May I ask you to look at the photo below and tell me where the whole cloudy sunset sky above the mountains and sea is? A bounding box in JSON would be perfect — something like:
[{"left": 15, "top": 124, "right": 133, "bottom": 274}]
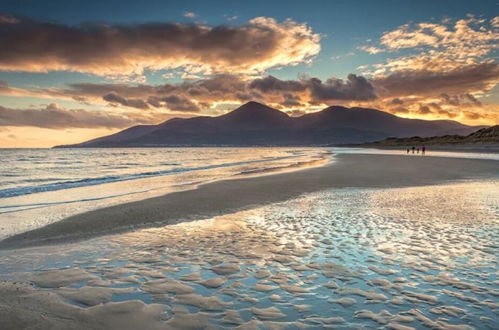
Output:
[{"left": 0, "top": 0, "right": 499, "bottom": 148}]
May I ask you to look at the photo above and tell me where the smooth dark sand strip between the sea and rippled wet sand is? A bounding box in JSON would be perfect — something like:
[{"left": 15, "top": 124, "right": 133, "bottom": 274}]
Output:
[{"left": 0, "top": 154, "right": 499, "bottom": 249}]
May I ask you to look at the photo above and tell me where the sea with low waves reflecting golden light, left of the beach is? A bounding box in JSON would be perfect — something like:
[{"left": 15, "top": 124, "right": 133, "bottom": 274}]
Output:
[{"left": 0, "top": 148, "right": 330, "bottom": 239}]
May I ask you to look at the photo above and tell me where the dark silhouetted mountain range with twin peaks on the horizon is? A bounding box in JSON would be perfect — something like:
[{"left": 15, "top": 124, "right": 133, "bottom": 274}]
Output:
[{"left": 58, "top": 102, "right": 483, "bottom": 148}]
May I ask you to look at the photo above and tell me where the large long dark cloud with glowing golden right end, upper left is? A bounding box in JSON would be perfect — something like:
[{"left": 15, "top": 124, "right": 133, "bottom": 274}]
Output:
[{"left": 0, "top": 16, "right": 320, "bottom": 76}]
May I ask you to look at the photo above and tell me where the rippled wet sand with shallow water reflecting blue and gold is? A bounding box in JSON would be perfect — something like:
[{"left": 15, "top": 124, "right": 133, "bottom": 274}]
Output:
[{"left": 0, "top": 181, "right": 499, "bottom": 329}]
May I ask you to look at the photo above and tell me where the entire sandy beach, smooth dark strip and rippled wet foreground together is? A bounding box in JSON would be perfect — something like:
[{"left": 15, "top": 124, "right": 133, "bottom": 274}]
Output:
[{"left": 0, "top": 153, "right": 499, "bottom": 329}]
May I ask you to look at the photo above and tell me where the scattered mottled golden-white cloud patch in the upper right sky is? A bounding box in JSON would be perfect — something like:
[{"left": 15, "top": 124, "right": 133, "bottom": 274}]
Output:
[{"left": 359, "top": 16, "right": 499, "bottom": 75}]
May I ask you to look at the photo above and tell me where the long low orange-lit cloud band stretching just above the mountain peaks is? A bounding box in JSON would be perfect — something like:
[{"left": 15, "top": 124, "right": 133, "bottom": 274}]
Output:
[{"left": 0, "top": 70, "right": 499, "bottom": 124}]
